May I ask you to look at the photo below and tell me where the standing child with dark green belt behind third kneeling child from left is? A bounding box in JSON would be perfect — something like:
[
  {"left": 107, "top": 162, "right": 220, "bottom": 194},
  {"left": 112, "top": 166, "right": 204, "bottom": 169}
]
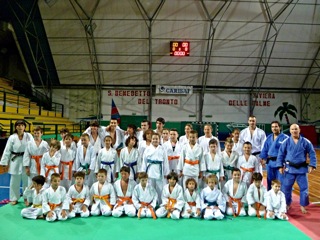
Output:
[{"left": 73, "top": 133, "right": 96, "bottom": 188}]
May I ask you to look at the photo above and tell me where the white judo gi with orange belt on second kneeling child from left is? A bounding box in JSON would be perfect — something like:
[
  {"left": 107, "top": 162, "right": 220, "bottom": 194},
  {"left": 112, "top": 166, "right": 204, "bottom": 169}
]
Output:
[{"left": 42, "top": 186, "right": 69, "bottom": 222}]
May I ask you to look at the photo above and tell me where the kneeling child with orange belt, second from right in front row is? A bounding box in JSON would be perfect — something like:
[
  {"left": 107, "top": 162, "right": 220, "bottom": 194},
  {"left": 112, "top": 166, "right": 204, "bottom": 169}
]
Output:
[{"left": 247, "top": 173, "right": 267, "bottom": 218}]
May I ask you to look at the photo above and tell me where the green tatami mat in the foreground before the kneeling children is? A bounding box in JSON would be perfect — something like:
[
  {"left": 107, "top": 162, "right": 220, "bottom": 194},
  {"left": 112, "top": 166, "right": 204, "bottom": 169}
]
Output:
[{"left": 0, "top": 203, "right": 309, "bottom": 240}]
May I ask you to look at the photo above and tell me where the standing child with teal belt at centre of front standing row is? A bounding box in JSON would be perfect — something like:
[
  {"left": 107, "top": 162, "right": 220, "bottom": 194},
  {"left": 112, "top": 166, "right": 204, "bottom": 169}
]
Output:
[{"left": 142, "top": 133, "right": 169, "bottom": 204}]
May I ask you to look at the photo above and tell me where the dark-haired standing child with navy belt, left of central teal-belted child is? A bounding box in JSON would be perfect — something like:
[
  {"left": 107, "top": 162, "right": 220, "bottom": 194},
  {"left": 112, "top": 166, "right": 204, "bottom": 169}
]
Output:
[{"left": 119, "top": 136, "right": 142, "bottom": 180}]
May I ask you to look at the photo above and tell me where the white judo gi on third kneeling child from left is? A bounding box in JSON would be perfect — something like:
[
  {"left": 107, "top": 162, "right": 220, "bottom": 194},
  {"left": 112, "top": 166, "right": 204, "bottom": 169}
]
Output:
[{"left": 67, "top": 184, "right": 91, "bottom": 218}]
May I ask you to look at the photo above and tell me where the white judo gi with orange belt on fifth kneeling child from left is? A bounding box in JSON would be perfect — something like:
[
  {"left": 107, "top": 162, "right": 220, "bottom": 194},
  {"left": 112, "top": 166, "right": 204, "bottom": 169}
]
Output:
[{"left": 112, "top": 179, "right": 137, "bottom": 217}]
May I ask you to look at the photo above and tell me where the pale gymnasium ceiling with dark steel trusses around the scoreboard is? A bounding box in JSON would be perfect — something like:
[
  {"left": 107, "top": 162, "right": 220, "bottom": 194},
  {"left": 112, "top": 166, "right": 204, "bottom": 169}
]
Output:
[{"left": 1, "top": 0, "right": 320, "bottom": 91}]
